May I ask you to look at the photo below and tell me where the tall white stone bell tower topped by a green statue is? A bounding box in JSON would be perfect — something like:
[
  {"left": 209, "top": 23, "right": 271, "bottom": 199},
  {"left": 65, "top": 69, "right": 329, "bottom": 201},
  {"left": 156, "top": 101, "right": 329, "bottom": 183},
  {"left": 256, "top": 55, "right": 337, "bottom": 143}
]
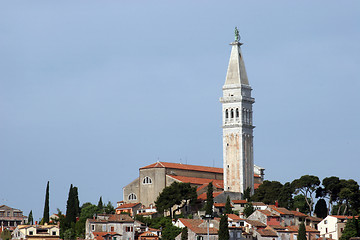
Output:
[{"left": 220, "top": 28, "right": 255, "bottom": 194}]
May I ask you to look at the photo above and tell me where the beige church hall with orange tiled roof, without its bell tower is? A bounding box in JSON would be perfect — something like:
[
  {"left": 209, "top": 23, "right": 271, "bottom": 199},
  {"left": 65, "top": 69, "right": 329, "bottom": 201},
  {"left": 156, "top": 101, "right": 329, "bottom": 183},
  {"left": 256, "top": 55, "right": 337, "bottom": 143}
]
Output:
[{"left": 123, "top": 162, "right": 264, "bottom": 206}]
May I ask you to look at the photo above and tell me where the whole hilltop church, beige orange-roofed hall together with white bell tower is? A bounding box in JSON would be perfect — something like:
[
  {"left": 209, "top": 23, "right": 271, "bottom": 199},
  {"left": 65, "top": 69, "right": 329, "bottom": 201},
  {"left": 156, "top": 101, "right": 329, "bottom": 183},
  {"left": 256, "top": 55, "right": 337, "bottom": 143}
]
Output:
[{"left": 123, "top": 29, "right": 265, "bottom": 206}]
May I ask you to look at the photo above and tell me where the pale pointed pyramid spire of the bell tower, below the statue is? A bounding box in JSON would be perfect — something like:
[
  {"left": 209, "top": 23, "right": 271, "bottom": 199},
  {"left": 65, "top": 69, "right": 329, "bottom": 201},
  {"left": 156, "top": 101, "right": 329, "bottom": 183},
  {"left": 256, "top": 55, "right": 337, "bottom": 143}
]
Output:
[{"left": 225, "top": 42, "right": 249, "bottom": 85}]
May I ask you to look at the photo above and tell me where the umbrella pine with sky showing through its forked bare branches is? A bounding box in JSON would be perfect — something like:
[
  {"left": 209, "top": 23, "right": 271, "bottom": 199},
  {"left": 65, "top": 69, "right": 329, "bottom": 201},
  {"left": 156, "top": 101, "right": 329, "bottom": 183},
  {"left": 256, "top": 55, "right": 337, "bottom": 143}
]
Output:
[{"left": 291, "top": 175, "right": 320, "bottom": 214}]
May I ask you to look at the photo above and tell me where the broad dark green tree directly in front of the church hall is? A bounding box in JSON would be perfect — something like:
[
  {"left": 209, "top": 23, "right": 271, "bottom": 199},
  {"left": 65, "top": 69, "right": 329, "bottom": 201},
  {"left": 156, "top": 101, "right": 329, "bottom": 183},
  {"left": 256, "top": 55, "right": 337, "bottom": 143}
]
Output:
[{"left": 155, "top": 182, "right": 197, "bottom": 218}]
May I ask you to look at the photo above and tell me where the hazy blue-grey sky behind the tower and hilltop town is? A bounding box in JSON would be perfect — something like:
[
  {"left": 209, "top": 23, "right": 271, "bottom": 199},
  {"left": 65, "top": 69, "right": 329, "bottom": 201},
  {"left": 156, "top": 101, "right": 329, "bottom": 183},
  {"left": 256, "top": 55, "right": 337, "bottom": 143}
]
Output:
[{"left": 0, "top": 0, "right": 360, "bottom": 220}]
